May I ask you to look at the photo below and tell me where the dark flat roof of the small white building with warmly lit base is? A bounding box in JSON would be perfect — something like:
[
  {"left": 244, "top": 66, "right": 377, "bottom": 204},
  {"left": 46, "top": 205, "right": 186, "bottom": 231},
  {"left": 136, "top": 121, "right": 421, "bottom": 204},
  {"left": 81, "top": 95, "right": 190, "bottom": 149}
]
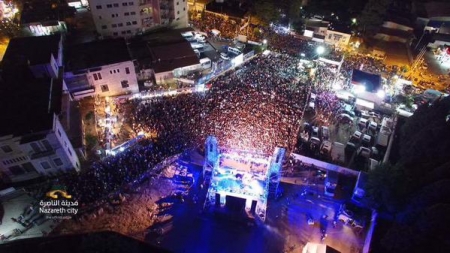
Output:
[{"left": 65, "top": 38, "right": 131, "bottom": 72}]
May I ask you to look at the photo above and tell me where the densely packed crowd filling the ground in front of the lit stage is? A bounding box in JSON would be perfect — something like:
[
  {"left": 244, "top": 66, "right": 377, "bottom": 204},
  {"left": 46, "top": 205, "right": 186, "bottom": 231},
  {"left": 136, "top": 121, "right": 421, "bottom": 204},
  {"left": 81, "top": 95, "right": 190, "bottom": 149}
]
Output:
[{"left": 134, "top": 54, "right": 308, "bottom": 152}]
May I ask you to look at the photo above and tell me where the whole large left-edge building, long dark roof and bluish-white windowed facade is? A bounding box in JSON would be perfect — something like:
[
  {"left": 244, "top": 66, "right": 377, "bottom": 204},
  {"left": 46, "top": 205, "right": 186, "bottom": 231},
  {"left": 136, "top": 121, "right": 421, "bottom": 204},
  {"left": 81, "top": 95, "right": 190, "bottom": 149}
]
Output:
[{"left": 0, "top": 35, "right": 80, "bottom": 182}]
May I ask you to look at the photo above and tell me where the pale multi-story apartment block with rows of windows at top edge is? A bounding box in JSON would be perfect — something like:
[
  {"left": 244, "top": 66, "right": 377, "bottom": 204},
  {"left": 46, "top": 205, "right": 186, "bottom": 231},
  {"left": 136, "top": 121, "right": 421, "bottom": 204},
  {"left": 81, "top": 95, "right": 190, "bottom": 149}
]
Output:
[{"left": 89, "top": 0, "right": 188, "bottom": 37}]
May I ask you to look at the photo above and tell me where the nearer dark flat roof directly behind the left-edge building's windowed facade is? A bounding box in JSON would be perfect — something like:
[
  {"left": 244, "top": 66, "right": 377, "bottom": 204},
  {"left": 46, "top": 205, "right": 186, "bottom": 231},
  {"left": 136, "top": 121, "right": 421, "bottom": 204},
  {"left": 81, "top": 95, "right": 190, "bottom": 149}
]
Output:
[{"left": 0, "top": 66, "right": 62, "bottom": 136}]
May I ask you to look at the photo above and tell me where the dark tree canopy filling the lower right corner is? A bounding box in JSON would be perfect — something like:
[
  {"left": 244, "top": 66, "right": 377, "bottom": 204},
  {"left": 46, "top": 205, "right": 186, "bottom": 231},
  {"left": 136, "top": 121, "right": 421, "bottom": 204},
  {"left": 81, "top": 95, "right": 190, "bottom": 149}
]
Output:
[{"left": 367, "top": 97, "right": 450, "bottom": 253}]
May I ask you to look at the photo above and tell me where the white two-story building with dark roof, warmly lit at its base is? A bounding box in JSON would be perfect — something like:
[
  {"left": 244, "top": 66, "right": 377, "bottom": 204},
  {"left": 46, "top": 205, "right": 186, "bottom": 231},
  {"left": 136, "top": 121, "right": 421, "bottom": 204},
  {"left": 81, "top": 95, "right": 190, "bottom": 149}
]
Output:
[{"left": 64, "top": 38, "right": 139, "bottom": 100}]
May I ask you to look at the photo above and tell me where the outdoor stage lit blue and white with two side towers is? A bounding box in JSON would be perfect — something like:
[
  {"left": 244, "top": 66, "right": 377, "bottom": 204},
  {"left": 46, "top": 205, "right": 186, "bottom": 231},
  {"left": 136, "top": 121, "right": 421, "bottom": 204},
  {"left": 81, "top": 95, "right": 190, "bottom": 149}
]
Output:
[{"left": 203, "top": 137, "right": 285, "bottom": 221}]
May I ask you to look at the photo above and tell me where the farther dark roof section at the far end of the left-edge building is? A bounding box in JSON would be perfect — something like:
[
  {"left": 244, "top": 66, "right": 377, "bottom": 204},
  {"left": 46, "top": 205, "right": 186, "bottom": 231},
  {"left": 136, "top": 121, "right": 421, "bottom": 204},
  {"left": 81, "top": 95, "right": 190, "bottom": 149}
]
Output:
[{"left": 2, "top": 34, "right": 61, "bottom": 68}]
